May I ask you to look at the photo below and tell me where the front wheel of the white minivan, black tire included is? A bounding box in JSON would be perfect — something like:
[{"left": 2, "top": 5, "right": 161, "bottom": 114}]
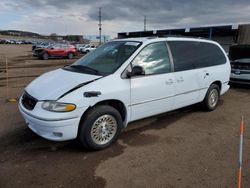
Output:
[{"left": 78, "top": 105, "right": 123, "bottom": 150}]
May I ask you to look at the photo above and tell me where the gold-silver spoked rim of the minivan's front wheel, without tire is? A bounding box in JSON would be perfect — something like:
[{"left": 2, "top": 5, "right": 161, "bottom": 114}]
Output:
[{"left": 91, "top": 115, "right": 117, "bottom": 145}]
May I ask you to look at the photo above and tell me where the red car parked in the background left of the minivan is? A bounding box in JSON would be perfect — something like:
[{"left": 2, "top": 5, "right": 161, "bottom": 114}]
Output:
[{"left": 33, "top": 44, "right": 77, "bottom": 60}]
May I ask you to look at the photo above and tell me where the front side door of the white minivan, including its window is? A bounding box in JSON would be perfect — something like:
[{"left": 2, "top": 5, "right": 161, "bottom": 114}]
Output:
[{"left": 130, "top": 42, "right": 175, "bottom": 121}]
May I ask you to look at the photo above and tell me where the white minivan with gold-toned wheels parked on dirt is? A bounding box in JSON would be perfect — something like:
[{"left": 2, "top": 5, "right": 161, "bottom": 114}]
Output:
[{"left": 19, "top": 37, "right": 230, "bottom": 149}]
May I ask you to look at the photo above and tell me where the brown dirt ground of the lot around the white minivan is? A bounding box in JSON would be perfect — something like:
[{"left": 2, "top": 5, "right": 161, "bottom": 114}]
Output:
[{"left": 0, "top": 45, "right": 250, "bottom": 188}]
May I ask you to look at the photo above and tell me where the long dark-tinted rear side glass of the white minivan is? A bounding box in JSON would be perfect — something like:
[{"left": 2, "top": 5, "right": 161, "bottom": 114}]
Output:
[{"left": 168, "top": 41, "right": 226, "bottom": 71}]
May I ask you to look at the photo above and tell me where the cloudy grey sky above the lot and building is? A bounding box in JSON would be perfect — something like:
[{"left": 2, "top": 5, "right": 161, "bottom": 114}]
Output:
[{"left": 0, "top": 0, "right": 250, "bottom": 37}]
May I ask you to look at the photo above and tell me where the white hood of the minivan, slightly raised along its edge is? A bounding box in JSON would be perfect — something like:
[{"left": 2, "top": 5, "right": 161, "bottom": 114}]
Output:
[{"left": 25, "top": 69, "right": 101, "bottom": 100}]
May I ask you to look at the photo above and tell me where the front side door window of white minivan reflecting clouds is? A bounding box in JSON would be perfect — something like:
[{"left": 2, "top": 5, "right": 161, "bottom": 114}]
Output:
[{"left": 132, "top": 42, "right": 171, "bottom": 75}]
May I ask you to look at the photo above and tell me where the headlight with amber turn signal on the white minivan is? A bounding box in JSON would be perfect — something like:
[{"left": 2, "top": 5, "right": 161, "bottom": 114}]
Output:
[{"left": 42, "top": 101, "right": 76, "bottom": 112}]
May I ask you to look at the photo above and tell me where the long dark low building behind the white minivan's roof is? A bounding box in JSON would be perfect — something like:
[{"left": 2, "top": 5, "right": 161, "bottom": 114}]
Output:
[{"left": 118, "top": 24, "right": 250, "bottom": 52}]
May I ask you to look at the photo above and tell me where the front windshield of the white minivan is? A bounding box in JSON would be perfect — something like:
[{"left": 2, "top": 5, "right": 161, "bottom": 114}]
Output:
[{"left": 65, "top": 41, "right": 141, "bottom": 75}]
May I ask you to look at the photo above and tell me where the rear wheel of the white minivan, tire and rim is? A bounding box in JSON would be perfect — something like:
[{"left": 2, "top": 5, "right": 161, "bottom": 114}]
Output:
[{"left": 203, "top": 84, "right": 220, "bottom": 111}]
